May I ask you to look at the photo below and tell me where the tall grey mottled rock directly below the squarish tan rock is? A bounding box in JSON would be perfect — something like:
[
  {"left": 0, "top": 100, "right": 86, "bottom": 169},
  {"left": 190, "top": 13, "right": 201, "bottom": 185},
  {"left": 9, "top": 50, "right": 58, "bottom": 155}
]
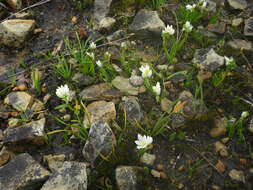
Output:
[{"left": 83, "top": 121, "right": 116, "bottom": 166}]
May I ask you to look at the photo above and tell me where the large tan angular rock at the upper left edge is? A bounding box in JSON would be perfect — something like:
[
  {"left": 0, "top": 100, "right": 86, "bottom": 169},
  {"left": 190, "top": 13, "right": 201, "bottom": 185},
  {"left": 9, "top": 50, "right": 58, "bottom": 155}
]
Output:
[{"left": 0, "top": 19, "right": 35, "bottom": 47}]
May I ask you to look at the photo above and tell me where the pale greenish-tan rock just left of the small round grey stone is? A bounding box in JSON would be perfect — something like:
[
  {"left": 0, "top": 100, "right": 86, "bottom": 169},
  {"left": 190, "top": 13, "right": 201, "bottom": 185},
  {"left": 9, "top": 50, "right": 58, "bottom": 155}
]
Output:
[{"left": 112, "top": 76, "right": 142, "bottom": 95}]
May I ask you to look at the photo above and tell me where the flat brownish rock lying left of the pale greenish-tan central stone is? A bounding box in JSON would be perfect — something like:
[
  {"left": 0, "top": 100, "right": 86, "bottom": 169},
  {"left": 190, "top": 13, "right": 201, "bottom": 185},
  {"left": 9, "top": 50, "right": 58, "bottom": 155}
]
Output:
[{"left": 79, "top": 83, "right": 122, "bottom": 100}]
